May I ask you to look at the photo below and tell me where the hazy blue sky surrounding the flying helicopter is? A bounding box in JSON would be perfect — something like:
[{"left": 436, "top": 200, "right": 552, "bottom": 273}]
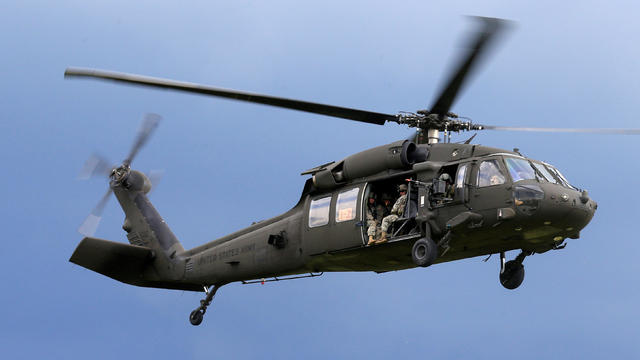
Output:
[{"left": 0, "top": 1, "right": 640, "bottom": 359}]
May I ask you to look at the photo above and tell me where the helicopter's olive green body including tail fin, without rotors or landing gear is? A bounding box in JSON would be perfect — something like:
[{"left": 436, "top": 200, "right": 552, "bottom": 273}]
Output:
[{"left": 70, "top": 141, "right": 597, "bottom": 291}]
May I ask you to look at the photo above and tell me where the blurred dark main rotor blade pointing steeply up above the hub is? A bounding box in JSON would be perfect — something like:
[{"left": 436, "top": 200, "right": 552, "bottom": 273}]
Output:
[{"left": 429, "top": 17, "right": 508, "bottom": 116}]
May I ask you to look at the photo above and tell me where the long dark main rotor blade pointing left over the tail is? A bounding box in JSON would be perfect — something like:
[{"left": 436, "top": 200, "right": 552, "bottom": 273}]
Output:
[{"left": 64, "top": 68, "right": 398, "bottom": 125}]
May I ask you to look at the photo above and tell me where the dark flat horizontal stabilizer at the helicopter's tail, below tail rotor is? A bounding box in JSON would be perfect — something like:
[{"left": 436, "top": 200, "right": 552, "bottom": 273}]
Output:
[{"left": 69, "top": 237, "right": 153, "bottom": 286}]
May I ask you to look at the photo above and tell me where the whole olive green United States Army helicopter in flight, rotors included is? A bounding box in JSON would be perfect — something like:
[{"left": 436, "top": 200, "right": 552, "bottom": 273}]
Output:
[{"left": 65, "top": 18, "right": 640, "bottom": 326}]
